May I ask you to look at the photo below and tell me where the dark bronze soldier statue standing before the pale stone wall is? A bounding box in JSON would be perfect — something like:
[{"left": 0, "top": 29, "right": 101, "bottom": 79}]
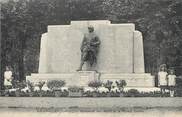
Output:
[{"left": 77, "top": 26, "right": 101, "bottom": 71}]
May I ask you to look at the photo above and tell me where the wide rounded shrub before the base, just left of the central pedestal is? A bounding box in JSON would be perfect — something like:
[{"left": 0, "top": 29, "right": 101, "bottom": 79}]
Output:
[{"left": 47, "top": 80, "right": 66, "bottom": 90}]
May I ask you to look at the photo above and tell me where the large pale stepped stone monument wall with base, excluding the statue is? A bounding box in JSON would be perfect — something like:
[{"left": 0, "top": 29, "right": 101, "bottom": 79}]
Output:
[{"left": 27, "top": 20, "right": 154, "bottom": 87}]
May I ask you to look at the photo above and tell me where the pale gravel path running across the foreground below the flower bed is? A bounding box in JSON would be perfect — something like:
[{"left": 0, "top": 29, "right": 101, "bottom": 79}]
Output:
[{"left": 0, "top": 97, "right": 182, "bottom": 110}]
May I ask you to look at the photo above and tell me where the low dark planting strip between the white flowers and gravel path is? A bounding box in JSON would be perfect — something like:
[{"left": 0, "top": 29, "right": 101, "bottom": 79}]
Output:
[{"left": 1, "top": 89, "right": 172, "bottom": 97}]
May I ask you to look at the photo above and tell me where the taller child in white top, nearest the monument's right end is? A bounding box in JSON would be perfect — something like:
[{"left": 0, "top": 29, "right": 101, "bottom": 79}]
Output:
[{"left": 158, "top": 64, "right": 168, "bottom": 97}]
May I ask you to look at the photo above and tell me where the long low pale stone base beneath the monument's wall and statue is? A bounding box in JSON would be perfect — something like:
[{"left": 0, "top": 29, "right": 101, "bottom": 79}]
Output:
[{"left": 26, "top": 71, "right": 155, "bottom": 87}]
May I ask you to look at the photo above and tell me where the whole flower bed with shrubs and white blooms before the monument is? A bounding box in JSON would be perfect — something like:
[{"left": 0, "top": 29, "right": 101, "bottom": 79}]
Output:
[{"left": 0, "top": 80, "right": 179, "bottom": 97}]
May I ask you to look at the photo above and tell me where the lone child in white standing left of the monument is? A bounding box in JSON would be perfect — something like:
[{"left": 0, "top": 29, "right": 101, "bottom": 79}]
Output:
[{"left": 4, "top": 66, "right": 13, "bottom": 89}]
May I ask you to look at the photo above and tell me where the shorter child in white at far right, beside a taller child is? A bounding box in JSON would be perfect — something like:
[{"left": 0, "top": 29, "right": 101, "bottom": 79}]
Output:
[{"left": 168, "top": 69, "right": 176, "bottom": 97}]
